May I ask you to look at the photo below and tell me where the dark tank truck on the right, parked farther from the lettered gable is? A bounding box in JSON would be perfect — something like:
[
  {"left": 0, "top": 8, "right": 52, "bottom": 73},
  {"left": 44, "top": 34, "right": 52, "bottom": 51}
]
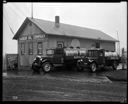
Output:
[{"left": 78, "top": 49, "right": 121, "bottom": 72}]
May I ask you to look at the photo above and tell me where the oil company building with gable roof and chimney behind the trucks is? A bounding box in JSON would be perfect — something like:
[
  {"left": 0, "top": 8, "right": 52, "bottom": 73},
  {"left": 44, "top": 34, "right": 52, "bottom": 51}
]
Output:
[{"left": 13, "top": 16, "right": 117, "bottom": 68}]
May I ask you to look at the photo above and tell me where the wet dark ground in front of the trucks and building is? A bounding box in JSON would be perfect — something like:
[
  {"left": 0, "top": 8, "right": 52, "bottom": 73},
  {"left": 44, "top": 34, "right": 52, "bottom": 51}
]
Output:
[{"left": 3, "top": 69, "right": 127, "bottom": 102}]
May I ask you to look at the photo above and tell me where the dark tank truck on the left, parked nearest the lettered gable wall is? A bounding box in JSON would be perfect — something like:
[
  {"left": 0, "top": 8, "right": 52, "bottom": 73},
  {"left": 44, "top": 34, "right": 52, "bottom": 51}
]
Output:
[{"left": 32, "top": 47, "right": 87, "bottom": 73}]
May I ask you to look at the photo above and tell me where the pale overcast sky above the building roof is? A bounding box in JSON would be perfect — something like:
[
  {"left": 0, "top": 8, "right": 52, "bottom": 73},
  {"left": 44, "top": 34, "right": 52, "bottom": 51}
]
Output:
[{"left": 3, "top": 2, "right": 127, "bottom": 53}]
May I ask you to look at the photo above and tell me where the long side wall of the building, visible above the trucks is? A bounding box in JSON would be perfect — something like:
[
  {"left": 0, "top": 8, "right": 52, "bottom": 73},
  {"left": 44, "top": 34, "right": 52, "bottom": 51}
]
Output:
[{"left": 48, "top": 35, "right": 115, "bottom": 51}]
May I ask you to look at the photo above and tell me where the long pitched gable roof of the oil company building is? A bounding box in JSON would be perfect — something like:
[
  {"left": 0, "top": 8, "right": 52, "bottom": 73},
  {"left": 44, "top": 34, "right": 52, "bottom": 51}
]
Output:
[{"left": 13, "top": 17, "right": 118, "bottom": 42}]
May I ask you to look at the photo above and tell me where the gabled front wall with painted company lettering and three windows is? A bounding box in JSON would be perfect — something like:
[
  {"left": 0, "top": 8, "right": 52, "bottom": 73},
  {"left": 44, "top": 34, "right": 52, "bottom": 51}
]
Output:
[{"left": 18, "top": 23, "right": 47, "bottom": 68}]
